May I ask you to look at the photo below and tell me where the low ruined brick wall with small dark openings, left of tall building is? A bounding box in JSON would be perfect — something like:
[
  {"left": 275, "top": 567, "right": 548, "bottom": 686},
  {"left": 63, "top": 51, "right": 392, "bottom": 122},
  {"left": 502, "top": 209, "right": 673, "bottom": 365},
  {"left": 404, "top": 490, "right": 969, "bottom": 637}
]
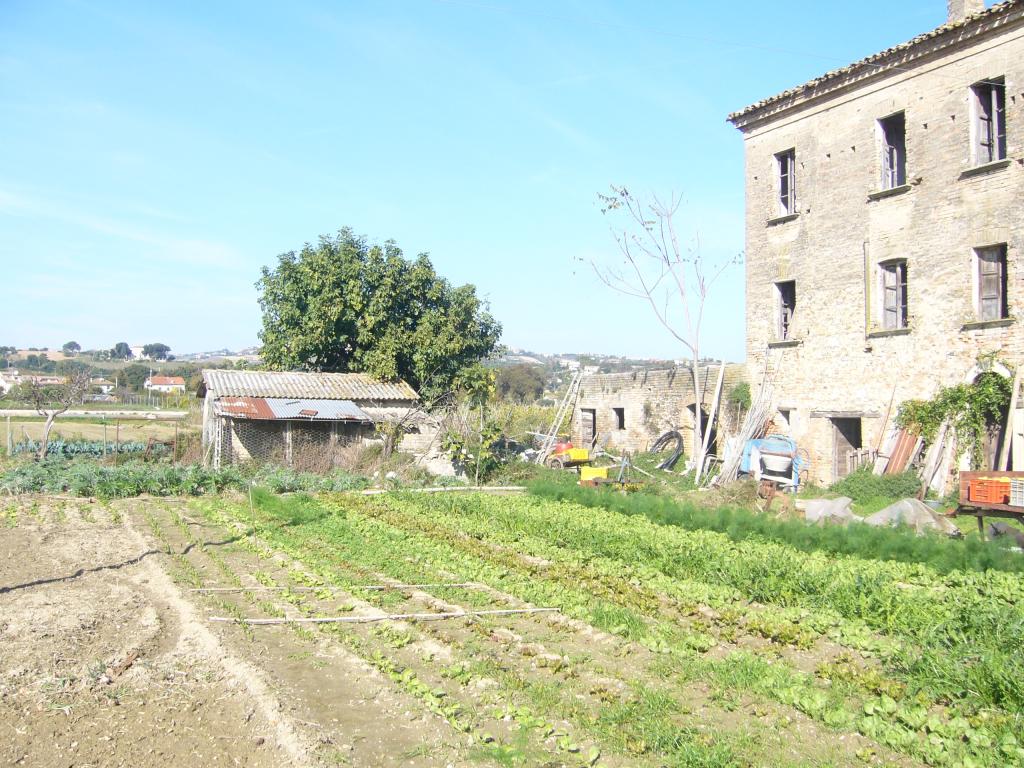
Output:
[{"left": 571, "top": 364, "right": 746, "bottom": 457}]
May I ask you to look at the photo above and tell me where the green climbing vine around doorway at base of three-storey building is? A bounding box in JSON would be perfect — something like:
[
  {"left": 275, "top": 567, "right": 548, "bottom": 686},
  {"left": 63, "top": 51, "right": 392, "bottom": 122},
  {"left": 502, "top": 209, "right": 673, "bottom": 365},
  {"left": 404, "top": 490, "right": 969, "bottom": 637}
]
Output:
[{"left": 896, "top": 356, "right": 1012, "bottom": 469}]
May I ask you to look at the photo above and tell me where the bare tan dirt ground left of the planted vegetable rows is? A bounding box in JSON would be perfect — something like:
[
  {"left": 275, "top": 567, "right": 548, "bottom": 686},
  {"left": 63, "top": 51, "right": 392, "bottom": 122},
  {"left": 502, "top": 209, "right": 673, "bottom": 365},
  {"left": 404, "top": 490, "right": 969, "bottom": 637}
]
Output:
[{"left": 0, "top": 500, "right": 462, "bottom": 766}]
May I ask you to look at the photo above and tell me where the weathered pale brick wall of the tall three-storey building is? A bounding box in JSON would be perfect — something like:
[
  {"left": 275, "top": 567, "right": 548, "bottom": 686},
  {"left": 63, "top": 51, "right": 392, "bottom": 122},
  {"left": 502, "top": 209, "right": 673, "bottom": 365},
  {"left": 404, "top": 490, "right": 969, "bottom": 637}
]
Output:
[{"left": 730, "top": 0, "right": 1024, "bottom": 482}]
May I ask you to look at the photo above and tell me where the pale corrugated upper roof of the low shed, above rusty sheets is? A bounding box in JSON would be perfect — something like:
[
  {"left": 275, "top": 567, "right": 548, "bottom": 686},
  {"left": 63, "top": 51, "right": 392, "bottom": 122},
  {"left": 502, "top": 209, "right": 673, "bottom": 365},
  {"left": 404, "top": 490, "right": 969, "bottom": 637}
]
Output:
[{"left": 200, "top": 369, "right": 420, "bottom": 401}]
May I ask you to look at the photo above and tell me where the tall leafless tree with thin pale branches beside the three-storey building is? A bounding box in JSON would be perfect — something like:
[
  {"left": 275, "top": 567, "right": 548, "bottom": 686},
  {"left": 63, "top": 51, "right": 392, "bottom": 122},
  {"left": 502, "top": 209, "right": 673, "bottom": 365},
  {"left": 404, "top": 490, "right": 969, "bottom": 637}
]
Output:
[{"left": 592, "top": 185, "right": 739, "bottom": 471}]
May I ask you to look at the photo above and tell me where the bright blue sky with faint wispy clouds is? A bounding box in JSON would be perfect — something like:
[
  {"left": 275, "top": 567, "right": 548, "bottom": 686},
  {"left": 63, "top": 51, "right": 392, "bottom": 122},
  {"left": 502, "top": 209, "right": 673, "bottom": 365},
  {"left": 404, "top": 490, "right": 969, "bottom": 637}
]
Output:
[{"left": 0, "top": 0, "right": 945, "bottom": 359}]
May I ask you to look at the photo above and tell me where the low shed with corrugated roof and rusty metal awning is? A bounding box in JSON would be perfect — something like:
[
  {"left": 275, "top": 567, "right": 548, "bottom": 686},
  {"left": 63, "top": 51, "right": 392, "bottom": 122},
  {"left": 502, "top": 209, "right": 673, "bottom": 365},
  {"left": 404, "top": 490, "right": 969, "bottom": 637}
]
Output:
[{"left": 196, "top": 369, "right": 420, "bottom": 467}]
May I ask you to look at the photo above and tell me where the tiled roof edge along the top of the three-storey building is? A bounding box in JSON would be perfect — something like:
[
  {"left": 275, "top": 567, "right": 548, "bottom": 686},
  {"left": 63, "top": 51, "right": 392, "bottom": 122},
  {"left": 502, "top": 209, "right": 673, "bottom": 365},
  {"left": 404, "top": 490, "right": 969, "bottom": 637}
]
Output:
[{"left": 727, "top": 0, "right": 1024, "bottom": 127}]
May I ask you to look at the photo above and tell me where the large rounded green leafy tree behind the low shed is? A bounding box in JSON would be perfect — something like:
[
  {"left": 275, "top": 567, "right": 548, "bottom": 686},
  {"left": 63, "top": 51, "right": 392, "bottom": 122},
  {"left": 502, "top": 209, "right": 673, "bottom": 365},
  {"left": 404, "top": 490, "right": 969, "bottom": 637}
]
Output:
[{"left": 256, "top": 228, "right": 501, "bottom": 400}]
